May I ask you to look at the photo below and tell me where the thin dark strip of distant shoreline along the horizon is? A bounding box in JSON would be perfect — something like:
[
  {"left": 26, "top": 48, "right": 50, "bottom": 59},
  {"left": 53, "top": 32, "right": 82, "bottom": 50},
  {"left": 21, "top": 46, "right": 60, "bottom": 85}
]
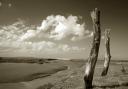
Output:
[{"left": 0, "top": 57, "right": 128, "bottom": 64}]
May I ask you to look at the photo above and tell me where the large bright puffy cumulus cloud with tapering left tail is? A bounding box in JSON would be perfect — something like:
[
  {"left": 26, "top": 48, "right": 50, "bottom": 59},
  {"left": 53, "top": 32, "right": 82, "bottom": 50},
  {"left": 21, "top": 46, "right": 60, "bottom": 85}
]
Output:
[{"left": 21, "top": 15, "right": 90, "bottom": 41}]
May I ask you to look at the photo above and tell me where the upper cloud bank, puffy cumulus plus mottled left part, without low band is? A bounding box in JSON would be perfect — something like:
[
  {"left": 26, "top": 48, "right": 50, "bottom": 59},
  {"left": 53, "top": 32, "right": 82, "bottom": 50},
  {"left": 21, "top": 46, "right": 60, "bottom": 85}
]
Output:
[{"left": 0, "top": 15, "right": 92, "bottom": 41}]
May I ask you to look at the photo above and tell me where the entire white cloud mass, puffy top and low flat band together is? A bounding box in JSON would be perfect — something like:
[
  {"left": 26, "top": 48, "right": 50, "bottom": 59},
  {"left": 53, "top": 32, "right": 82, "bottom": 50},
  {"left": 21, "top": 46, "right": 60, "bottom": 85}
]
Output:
[{"left": 0, "top": 15, "right": 92, "bottom": 56}]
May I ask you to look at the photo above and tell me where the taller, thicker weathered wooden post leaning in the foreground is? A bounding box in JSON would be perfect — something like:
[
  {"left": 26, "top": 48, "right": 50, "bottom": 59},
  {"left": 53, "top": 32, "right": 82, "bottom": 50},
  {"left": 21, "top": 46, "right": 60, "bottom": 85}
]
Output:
[{"left": 84, "top": 8, "right": 101, "bottom": 89}]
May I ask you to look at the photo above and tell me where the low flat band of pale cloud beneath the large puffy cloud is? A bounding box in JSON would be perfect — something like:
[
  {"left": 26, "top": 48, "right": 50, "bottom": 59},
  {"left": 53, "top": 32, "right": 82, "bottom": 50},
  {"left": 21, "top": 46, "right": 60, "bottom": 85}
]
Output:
[{"left": 0, "top": 41, "right": 85, "bottom": 54}]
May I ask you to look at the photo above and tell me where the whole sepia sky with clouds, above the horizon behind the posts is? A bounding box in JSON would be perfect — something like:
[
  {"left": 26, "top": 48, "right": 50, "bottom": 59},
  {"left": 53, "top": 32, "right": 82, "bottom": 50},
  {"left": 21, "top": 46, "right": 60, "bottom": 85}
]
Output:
[{"left": 0, "top": 0, "right": 128, "bottom": 59}]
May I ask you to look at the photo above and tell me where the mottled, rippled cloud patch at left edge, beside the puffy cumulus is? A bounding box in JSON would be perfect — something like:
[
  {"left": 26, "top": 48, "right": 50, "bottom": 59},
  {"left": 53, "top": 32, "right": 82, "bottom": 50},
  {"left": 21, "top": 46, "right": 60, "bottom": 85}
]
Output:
[{"left": 0, "top": 19, "right": 35, "bottom": 41}]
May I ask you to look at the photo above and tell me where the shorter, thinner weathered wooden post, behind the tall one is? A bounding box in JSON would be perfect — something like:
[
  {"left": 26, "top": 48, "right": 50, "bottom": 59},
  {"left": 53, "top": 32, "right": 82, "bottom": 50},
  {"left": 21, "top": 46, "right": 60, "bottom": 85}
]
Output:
[{"left": 101, "top": 29, "right": 111, "bottom": 76}]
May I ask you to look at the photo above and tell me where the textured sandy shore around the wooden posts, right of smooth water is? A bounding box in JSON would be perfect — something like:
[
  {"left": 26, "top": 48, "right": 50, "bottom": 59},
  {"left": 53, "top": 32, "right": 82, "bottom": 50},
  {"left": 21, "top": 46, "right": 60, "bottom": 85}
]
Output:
[{"left": 0, "top": 60, "right": 128, "bottom": 89}]
